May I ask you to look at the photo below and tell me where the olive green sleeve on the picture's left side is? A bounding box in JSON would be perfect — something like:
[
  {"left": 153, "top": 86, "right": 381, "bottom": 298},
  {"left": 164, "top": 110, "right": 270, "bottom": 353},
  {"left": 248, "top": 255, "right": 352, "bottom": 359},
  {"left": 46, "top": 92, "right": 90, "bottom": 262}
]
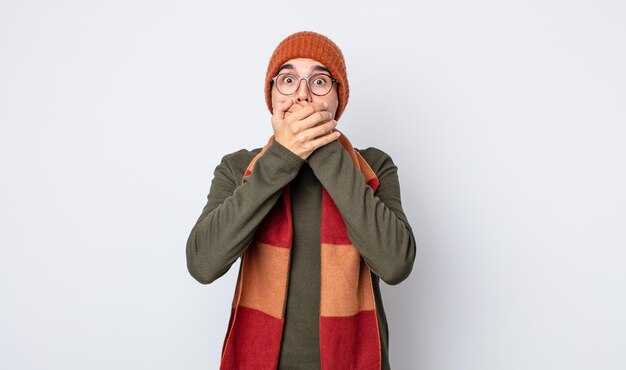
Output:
[{"left": 186, "top": 141, "right": 304, "bottom": 284}]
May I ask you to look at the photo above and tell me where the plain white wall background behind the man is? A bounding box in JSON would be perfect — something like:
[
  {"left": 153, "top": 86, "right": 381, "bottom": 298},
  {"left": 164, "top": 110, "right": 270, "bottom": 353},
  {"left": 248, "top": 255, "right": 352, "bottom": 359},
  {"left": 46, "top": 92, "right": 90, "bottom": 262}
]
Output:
[{"left": 0, "top": 0, "right": 626, "bottom": 370}]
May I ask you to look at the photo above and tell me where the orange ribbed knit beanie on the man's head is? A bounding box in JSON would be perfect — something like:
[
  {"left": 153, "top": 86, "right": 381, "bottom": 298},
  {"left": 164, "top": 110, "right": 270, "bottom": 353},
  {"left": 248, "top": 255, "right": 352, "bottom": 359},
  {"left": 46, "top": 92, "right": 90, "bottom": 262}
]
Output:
[{"left": 265, "top": 31, "right": 350, "bottom": 120}]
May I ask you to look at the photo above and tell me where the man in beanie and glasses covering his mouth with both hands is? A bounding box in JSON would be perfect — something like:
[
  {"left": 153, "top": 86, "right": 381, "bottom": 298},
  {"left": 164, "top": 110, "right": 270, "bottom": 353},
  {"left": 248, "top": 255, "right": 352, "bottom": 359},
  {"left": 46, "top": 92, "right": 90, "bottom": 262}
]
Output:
[{"left": 187, "top": 32, "right": 416, "bottom": 369}]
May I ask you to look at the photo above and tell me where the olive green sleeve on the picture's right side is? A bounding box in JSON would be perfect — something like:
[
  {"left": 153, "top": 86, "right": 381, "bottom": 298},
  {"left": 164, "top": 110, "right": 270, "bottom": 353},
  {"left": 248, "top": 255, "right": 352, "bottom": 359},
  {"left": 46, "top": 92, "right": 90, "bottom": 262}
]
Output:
[{"left": 307, "top": 140, "right": 416, "bottom": 285}]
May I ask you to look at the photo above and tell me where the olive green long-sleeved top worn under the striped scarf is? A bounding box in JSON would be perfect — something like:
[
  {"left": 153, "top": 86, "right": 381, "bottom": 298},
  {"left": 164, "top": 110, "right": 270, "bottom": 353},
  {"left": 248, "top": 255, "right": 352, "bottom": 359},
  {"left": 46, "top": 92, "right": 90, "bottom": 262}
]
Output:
[{"left": 186, "top": 140, "right": 416, "bottom": 369}]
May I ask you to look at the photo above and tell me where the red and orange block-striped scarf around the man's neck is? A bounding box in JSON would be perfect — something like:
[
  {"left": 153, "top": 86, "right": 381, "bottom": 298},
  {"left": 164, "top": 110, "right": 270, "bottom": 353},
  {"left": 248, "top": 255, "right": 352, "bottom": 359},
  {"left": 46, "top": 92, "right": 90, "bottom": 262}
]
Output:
[{"left": 220, "top": 134, "right": 381, "bottom": 370}]
